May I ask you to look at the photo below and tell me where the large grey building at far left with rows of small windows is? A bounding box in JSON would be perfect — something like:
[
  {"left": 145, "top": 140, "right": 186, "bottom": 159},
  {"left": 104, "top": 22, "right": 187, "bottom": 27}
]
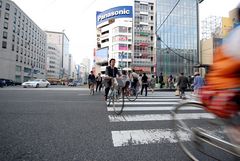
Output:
[{"left": 0, "top": 0, "right": 47, "bottom": 82}]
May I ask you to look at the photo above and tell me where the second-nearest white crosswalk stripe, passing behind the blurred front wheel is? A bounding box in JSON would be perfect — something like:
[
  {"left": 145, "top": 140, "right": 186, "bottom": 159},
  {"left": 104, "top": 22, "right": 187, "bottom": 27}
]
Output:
[{"left": 108, "top": 113, "right": 215, "bottom": 122}]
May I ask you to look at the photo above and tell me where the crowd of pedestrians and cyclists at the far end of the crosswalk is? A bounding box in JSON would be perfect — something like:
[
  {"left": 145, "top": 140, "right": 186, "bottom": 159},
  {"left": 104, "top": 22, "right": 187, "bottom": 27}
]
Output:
[{"left": 88, "top": 59, "right": 205, "bottom": 99}]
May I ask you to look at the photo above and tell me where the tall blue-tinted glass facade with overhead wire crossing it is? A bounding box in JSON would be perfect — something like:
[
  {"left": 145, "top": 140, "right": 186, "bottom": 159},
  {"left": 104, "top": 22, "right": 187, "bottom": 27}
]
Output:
[{"left": 157, "top": 0, "right": 198, "bottom": 76}]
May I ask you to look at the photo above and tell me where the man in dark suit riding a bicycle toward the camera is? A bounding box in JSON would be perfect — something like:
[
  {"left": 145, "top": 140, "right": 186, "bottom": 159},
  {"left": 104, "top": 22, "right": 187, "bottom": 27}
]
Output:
[{"left": 104, "top": 58, "right": 121, "bottom": 101}]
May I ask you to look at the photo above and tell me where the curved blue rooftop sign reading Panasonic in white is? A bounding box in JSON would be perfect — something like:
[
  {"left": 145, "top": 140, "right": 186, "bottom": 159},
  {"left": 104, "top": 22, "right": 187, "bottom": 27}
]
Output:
[{"left": 96, "top": 6, "right": 133, "bottom": 25}]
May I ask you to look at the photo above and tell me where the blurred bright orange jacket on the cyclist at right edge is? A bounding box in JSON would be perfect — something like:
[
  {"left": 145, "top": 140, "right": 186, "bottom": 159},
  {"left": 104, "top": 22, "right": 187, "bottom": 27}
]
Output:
[{"left": 206, "top": 46, "right": 240, "bottom": 89}]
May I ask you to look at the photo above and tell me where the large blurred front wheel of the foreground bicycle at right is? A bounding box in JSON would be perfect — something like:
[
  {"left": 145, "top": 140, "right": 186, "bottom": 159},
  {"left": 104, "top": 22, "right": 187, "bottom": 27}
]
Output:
[{"left": 172, "top": 102, "right": 232, "bottom": 160}]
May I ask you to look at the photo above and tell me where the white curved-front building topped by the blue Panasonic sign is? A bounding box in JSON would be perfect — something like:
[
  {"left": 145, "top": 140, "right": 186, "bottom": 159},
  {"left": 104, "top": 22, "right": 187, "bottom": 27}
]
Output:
[{"left": 94, "top": 6, "right": 133, "bottom": 73}]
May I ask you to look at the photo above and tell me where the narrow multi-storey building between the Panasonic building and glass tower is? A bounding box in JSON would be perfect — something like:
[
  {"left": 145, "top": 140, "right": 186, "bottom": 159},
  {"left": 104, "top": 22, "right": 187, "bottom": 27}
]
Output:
[{"left": 132, "top": 0, "right": 156, "bottom": 73}]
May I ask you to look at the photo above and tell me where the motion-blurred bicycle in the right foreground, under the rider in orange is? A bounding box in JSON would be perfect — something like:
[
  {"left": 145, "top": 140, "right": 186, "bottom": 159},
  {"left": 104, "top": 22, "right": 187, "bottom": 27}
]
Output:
[{"left": 172, "top": 100, "right": 240, "bottom": 160}]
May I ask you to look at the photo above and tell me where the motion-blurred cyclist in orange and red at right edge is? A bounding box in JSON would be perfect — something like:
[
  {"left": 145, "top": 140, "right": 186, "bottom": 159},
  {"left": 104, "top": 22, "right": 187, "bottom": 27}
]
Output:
[{"left": 201, "top": 4, "right": 240, "bottom": 145}]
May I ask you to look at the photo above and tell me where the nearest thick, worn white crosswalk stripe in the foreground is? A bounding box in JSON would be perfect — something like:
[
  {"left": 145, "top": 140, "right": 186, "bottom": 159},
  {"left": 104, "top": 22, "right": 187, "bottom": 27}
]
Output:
[{"left": 112, "top": 129, "right": 190, "bottom": 147}]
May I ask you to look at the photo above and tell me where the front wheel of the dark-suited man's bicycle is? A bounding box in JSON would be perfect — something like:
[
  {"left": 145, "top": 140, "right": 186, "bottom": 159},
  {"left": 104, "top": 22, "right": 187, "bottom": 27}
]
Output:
[{"left": 112, "top": 90, "right": 124, "bottom": 115}]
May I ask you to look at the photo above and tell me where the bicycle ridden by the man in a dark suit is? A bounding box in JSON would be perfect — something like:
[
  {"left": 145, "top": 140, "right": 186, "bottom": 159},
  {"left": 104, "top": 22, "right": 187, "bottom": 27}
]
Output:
[{"left": 107, "top": 78, "right": 124, "bottom": 115}]
